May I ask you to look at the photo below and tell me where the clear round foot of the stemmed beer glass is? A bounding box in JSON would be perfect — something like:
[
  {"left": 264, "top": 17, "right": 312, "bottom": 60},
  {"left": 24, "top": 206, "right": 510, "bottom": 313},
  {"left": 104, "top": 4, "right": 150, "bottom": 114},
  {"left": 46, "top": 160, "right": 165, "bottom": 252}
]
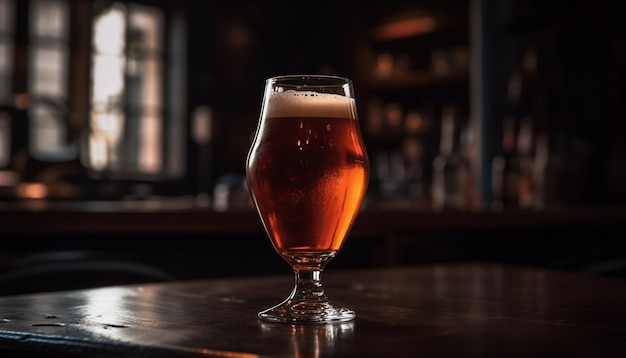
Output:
[{"left": 258, "top": 299, "right": 356, "bottom": 324}]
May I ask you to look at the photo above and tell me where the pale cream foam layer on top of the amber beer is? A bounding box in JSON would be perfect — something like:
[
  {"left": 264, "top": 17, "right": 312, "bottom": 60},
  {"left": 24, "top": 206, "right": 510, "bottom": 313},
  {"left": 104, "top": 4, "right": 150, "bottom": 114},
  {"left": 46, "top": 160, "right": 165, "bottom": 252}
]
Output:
[{"left": 264, "top": 90, "right": 356, "bottom": 118}]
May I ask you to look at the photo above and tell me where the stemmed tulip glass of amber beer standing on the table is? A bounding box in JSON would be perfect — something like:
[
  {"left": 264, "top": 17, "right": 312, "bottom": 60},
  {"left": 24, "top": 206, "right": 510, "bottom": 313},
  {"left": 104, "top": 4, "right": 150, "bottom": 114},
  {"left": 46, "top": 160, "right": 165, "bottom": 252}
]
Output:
[{"left": 246, "top": 75, "right": 369, "bottom": 324}]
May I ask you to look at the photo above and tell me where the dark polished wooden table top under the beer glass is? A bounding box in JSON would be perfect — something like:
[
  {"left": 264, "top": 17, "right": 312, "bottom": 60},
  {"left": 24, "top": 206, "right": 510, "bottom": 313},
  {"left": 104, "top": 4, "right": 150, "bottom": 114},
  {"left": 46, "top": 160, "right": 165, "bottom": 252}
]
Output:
[{"left": 0, "top": 263, "right": 626, "bottom": 357}]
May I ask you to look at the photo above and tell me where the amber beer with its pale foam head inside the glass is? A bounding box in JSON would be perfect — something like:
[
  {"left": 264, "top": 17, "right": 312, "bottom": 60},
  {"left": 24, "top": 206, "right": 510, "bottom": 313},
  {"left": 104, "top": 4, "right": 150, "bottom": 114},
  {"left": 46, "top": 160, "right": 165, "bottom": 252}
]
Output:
[{"left": 246, "top": 91, "right": 369, "bottom": 255}]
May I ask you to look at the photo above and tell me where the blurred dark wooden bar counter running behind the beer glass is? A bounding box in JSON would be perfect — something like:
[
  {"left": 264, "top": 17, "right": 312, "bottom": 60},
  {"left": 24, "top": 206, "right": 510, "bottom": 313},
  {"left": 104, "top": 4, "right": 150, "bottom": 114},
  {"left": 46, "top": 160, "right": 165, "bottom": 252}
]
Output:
[{"left": 0, "top": 198, "right": 626, "bottom": 238}]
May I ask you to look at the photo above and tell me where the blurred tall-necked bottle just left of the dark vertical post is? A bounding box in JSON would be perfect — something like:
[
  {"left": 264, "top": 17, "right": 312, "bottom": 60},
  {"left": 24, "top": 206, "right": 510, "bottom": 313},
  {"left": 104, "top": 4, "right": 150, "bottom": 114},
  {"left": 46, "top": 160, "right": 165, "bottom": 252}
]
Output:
[{"left": 431, "top": 105, "right": 471, "bottom": 211}]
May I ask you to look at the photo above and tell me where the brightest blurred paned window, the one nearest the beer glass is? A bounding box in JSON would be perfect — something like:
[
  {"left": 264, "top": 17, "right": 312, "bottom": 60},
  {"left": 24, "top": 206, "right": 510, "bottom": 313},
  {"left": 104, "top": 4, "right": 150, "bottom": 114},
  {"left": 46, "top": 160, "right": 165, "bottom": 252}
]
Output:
[{"left": 88, "top": 2, "right": 183, "bottom": 178}]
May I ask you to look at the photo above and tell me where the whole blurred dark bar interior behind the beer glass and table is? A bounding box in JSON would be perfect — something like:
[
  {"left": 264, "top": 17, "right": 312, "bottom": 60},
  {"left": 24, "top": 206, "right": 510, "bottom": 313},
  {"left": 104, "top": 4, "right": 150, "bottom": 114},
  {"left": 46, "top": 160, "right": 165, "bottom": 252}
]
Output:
[{"left": 0, "top": 0, "right": 626, "bottom": 294}]
